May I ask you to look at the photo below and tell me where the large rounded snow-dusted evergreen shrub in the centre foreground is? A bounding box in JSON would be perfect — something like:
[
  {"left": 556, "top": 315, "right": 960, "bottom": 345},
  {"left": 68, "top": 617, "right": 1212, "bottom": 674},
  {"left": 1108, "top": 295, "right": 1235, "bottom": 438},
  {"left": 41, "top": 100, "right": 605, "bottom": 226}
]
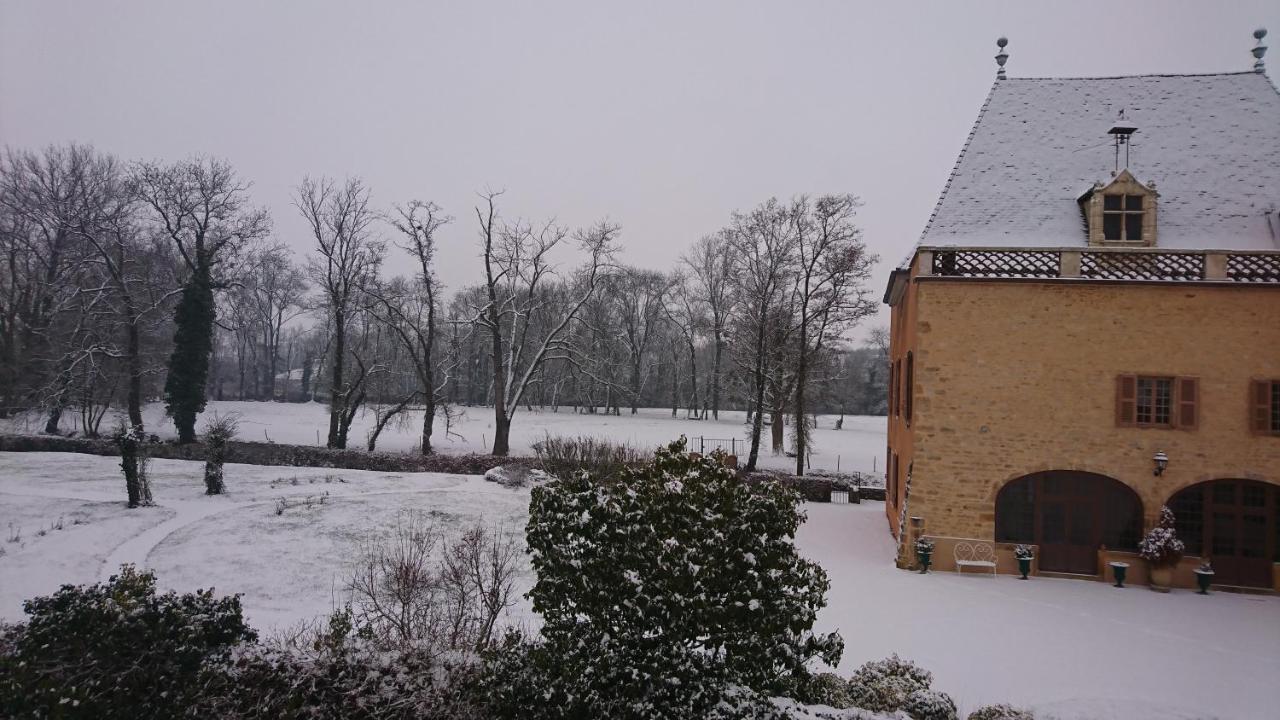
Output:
[{"left": 526, "top": 439, "right": 844, "bottom": 717}]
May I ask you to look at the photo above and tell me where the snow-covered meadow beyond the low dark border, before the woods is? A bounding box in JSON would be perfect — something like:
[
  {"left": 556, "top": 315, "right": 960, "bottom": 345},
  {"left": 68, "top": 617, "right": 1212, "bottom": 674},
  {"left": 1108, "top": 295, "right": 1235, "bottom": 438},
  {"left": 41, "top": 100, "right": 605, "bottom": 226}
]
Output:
[{"left": 0, "top": 401, "right": 886, "bottom": 473}]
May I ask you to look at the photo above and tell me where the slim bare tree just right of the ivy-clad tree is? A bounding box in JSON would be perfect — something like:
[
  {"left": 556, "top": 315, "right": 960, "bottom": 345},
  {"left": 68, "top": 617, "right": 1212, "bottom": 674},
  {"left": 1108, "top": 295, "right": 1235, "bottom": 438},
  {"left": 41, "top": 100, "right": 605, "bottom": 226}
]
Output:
[{"left": 294, "top": 178, "right": 385, "bottom": 448}]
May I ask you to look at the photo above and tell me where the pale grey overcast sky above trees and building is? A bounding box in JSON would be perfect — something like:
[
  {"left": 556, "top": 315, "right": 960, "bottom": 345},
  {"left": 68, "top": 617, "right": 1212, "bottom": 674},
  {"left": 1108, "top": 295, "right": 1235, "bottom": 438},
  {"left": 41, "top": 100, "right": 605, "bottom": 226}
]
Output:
[{"left": 0, "top": 0, "right": 1280, "bottom": 335}]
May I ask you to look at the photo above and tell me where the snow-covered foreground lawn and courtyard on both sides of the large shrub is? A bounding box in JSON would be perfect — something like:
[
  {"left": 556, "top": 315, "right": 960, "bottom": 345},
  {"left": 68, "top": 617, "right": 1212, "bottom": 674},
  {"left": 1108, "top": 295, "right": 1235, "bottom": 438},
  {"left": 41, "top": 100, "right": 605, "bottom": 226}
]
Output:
[{"left": 0, "top": 450, "right": 1280, "bottom": 720}]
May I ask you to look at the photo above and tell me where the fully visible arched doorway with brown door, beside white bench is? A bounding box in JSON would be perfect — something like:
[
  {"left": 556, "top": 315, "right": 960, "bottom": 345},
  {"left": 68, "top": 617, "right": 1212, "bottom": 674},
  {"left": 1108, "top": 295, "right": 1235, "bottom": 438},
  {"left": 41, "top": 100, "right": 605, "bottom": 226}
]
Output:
[{"left": 996, "top": 470, "right": 1142, "bottom": 575}]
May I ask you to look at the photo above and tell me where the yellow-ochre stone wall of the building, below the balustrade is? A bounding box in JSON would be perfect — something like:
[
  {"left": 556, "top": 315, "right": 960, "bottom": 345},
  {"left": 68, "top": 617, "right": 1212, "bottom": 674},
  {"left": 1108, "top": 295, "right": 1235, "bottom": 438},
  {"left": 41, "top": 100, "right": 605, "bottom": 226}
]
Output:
[{"left": 886, "top": 249, "right": 1280, "bottom": 579}]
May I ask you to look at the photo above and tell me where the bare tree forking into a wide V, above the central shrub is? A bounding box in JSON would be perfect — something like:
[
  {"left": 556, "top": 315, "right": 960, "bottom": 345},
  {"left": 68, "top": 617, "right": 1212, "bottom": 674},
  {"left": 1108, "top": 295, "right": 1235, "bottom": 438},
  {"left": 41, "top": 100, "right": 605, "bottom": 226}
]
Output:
[{"left": 475, "top": 192, "right": 618, "bottom": 455}]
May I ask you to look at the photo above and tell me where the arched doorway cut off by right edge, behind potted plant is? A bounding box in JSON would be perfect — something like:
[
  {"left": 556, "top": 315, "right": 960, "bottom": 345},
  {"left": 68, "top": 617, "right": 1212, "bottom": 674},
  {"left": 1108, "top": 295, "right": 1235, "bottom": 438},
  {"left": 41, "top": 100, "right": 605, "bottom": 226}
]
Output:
[{"left": 1169, "top": 479, "right": 1280, "bottom": 588}]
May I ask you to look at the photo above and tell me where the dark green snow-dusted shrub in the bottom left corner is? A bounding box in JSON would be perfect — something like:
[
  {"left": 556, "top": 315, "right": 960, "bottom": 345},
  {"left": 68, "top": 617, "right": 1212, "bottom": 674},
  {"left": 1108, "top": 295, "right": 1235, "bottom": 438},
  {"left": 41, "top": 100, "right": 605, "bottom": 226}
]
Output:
[{"left": 0, "top": 565, "right": 256, "bottom": 719}]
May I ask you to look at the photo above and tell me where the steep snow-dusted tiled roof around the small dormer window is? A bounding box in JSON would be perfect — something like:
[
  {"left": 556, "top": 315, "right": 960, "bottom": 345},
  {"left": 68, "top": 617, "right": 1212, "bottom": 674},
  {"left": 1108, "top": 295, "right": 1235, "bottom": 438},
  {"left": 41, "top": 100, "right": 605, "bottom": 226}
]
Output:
[{"left": 920, "top": 72, "right": 1280, "bottom": 250}]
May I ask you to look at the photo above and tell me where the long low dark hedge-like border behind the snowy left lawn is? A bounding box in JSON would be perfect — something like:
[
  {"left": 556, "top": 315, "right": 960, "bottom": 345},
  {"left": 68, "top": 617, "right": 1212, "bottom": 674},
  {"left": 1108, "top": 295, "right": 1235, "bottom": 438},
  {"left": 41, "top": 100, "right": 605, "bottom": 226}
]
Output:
[{"left": 0, "top": 434, "right": 536, "bottom": 475}]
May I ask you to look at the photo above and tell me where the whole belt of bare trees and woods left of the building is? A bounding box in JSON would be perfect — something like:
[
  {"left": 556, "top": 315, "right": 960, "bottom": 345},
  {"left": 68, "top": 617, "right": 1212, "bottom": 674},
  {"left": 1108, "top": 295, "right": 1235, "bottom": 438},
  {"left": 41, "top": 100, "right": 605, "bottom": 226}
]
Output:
[{"left": 0, "top": 145, "right": 887, "bottom": 470}]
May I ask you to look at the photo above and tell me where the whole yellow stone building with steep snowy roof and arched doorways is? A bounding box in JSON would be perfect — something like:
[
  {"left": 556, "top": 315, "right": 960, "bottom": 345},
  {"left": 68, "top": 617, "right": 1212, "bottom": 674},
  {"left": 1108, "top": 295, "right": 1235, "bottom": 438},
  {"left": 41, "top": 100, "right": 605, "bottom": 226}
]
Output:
[{"left": 884, "top": 31, "right": 1280, "bottom": 589}]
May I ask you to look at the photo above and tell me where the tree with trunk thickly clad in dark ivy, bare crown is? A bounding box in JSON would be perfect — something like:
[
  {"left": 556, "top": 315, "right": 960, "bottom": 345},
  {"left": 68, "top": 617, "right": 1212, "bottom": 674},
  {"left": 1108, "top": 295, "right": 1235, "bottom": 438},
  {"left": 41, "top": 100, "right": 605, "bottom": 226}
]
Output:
[{"left": 134, "top": 158, "right": 270, "bottom": 443}]
